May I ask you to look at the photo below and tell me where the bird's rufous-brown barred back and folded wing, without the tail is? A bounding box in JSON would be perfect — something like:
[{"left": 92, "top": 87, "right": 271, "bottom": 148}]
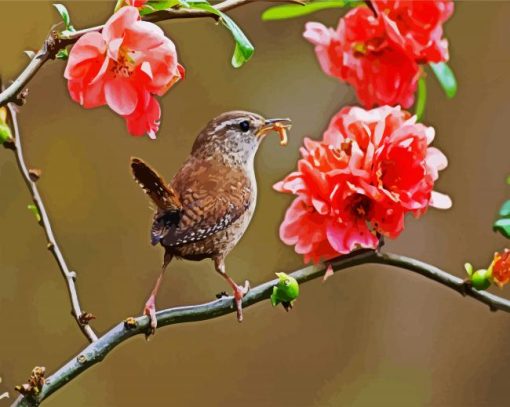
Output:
[{"left": 162, "top": 159, "right": 252, "bottom": 246}]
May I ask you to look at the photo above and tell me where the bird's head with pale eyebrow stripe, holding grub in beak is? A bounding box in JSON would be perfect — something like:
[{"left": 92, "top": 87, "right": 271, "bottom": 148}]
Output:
[{"left": 192, "top": 110, "right": 291, "bottom": 165}]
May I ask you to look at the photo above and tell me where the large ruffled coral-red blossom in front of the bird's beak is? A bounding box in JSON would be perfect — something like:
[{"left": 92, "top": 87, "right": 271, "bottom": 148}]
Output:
[{"left": 274, "top": 106, "right": 451, "bottom": 262}]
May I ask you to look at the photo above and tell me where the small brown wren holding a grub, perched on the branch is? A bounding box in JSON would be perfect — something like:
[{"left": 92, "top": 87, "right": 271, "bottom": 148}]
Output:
[{"left": 131, "top": 111, "right": 291, "bottom": 334}]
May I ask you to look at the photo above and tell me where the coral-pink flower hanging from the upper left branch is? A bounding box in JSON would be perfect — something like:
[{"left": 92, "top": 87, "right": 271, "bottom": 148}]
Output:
[{"left": 64, "top": 6, "right": 184, "bottom": 138}]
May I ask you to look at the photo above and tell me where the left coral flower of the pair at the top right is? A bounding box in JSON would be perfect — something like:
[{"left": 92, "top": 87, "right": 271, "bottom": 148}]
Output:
[{"left": 304, "top": 7, "right": 420, "bottom": 108}]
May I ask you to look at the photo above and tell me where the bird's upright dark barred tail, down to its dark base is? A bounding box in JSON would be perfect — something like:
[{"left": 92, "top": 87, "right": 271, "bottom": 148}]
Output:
[{"left": 131, "top": 158, "right": 182, "bottom": 244}]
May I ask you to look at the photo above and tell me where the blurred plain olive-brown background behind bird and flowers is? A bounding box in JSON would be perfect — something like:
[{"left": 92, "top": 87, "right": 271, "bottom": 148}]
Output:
[{"left": 0, "top": 1, "right": 510, "bottom": 407}]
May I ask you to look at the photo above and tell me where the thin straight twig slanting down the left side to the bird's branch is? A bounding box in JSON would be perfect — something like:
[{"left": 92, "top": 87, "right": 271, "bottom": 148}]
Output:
[{"left": 7, "top": 104, "right": 97, "bottom": 342}]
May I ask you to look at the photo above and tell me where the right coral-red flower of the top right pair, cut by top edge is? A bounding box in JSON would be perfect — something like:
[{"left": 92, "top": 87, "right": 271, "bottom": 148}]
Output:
[{"left": 372, "top": 0, "right": 454, "bottom": 63}]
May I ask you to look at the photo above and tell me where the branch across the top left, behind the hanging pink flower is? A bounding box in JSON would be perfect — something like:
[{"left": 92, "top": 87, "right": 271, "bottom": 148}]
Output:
[{"left": 0, "top": 0, "right": 303, "bottom": 107}]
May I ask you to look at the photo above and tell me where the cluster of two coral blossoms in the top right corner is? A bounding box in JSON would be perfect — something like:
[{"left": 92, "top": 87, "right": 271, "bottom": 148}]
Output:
[{"left": 304, "top": 0, "right": 454, "bottom": 108}]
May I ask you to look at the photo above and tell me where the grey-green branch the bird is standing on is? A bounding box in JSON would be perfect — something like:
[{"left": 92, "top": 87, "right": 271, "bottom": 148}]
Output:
[{"left": 9, "top": 249, "right": 510, "bottom": 406}]
